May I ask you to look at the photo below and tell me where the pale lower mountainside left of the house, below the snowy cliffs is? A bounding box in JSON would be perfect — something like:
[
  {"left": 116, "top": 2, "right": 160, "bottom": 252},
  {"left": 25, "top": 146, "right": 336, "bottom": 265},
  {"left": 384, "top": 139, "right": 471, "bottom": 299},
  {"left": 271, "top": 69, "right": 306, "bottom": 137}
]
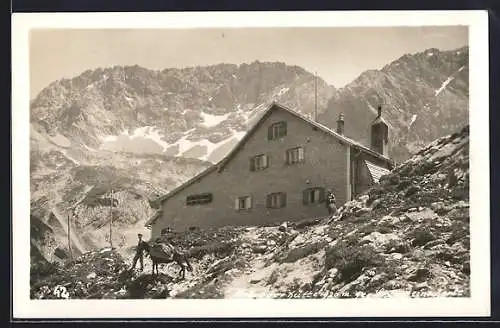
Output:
[{"left": 30, "top": 125, "right": 209, "bottom": 261}]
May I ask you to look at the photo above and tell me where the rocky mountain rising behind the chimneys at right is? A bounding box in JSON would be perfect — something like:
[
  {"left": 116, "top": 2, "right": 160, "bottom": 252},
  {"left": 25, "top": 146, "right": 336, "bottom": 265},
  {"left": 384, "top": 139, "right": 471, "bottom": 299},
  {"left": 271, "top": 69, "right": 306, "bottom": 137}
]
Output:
[{"left": 319, "top": 47, "right": 469, "bottom": 162}]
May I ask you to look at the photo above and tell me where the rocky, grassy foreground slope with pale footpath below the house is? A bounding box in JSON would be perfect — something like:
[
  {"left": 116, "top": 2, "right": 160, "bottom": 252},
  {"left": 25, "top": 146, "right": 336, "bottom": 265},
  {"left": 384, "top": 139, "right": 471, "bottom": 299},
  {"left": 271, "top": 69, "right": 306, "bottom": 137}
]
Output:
[{"left": 31, "top": 126, "right": 470, "bottom": 298}]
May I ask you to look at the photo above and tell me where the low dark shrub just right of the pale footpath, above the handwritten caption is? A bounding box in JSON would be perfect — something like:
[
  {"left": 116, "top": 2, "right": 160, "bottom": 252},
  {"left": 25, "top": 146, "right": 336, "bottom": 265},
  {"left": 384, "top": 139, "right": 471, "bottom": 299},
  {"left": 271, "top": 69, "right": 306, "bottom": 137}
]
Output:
[{"left": 325, "top": 242, "right": 383, "bottom": 282}]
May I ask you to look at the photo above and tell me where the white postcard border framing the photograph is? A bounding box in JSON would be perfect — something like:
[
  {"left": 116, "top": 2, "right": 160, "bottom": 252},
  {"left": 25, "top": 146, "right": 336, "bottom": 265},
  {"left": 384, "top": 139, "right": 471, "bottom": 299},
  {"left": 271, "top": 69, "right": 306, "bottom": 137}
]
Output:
[{"left": 12, "top": 11, "right": 491, "bottom": 319}]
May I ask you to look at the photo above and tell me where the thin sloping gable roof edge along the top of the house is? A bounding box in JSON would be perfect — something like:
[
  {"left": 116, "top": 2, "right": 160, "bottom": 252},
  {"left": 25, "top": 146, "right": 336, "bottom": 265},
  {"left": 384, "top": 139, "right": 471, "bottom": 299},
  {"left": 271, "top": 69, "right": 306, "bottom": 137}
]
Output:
[{"left": 146, "top": 102, "right": 392, "bottom": 214}]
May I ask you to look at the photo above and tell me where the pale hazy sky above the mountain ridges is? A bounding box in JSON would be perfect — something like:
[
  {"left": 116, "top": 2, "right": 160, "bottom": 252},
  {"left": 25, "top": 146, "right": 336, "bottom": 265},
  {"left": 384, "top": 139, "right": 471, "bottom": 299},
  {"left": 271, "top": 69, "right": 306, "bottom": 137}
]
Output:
[{"left": 30, "top": 26, "right": 468, "bottom": 98}]
